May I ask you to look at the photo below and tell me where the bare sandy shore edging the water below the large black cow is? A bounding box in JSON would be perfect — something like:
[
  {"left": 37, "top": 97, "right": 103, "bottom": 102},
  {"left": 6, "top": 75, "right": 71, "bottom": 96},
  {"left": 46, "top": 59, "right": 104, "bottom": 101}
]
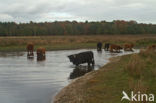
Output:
[{"left": 51, "top": 71, "right": 97, "bottom": 103}]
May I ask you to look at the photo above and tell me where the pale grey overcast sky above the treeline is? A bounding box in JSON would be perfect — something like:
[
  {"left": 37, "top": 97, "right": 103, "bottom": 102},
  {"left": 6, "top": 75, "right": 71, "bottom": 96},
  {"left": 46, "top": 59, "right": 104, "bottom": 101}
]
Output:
[{"left": 0, "top": 0, "right": 156, "bottom": 24}]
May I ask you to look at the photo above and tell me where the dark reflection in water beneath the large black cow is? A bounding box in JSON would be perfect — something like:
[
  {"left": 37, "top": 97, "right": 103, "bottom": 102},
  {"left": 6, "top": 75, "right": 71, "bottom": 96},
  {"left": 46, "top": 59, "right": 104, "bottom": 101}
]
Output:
[{"left": 69, "top": 65, "right": 94, "bottom": 79}]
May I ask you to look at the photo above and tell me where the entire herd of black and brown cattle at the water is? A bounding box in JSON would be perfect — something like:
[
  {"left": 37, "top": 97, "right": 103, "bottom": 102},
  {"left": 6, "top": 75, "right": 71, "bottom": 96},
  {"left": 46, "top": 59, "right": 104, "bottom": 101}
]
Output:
[{"left": 26, "top": 42, "right": 156, "bottom": 66}]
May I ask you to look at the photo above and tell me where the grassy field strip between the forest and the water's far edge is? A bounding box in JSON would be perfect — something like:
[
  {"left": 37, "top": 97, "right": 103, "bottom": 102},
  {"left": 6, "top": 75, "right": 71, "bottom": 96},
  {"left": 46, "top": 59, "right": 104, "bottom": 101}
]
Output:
[{"left": 0, "top": 35, "right": 156, "bottom": 51}]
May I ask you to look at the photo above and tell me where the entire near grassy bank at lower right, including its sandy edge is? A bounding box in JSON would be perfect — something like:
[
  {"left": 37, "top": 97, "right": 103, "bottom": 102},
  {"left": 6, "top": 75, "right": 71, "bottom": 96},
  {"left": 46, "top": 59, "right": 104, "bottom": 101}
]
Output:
[{"left": 54, "top": 51, "right": 156, "bottom": 103}]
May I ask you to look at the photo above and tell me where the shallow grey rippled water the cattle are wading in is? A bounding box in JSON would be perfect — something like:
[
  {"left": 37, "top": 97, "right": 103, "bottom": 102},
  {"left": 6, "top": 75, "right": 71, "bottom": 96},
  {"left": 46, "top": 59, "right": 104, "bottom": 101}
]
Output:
[{"left": 0, "top": 49, "right": 138, "bottom": 103}]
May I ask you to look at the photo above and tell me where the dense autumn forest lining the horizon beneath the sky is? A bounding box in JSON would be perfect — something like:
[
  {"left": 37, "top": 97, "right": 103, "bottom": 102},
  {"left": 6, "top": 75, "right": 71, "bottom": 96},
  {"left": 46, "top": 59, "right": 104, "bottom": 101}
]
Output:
[{"left": 0, "top": 20, "right": 156, "bottom": 36}]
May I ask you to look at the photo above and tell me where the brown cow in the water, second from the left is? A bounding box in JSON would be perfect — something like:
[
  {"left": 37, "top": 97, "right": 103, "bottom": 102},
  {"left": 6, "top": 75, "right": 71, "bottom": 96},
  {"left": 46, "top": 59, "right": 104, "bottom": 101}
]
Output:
[{"left": 37, "top": 47, "right": 46, "bottom": 61}]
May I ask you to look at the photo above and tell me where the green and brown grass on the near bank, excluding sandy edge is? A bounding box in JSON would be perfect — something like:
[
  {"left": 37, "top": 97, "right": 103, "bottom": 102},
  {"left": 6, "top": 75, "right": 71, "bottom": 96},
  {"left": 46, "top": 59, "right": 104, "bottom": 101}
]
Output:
[{"left": 84, "top": 51, "right": 156, "bottom": 103}]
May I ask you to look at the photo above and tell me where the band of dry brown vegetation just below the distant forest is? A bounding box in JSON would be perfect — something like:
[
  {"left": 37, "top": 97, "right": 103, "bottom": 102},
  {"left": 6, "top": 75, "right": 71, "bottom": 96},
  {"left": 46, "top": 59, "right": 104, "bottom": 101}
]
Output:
[{"left": 0, "top": 35, "right": 156, "bottom": 46}]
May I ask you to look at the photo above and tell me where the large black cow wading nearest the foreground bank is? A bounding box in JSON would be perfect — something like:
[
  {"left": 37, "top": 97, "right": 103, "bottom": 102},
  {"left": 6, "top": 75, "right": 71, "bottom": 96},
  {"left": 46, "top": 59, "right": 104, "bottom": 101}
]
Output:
[{"left": 68, "top": 51, "right": 94, "bottom": 66}]
